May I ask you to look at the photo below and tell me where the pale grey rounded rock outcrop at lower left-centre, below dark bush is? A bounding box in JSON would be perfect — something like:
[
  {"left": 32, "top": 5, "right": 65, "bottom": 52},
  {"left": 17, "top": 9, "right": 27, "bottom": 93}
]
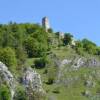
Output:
[{"left": 23, "top": 68, "right": 44, "bottom": 92}]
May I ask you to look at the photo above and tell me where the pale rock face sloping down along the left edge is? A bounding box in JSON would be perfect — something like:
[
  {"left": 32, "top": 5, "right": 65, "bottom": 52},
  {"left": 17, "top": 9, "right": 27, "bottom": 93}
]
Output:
[{"left": 0, "top": 62, "right": 15, "bottom": 100}]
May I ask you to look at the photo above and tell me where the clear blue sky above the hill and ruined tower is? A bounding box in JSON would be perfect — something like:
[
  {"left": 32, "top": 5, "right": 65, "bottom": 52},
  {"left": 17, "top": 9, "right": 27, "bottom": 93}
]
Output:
[{"left": 0, "top": 0, "right": 100, "bottom": 46}]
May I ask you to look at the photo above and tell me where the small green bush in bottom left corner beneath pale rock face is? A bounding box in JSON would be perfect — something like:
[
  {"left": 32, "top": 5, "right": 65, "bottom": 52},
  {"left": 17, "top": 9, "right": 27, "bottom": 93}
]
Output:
[{"left": 0, "top": 85, "right": 11, "bottom": 100}]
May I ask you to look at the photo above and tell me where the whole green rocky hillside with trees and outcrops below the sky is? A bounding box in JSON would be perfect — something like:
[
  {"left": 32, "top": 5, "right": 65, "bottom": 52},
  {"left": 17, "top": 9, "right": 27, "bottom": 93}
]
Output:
[{"left": 0, "top": 22, "right": 100, "bottom": 100}]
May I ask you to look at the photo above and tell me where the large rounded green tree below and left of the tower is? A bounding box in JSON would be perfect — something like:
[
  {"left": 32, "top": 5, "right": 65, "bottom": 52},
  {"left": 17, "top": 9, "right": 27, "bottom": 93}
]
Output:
[{"left": 24, "top": 29, "right": 48, "bottom": 57}]
